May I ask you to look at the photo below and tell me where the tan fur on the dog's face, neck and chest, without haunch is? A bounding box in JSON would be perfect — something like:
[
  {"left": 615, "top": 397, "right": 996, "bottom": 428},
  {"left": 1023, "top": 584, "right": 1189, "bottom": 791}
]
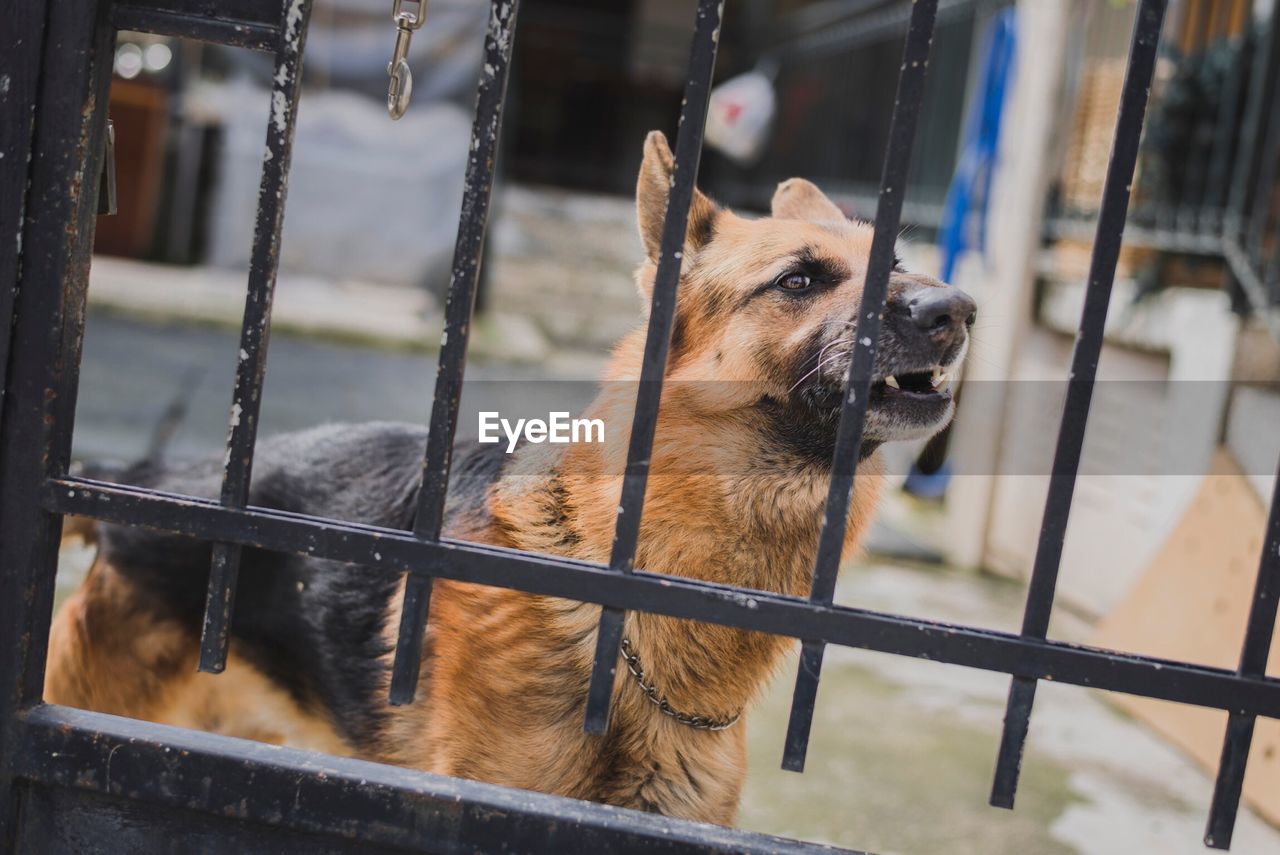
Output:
[{"left": 373, "top": 134, "right": 882, "bottom": 823}]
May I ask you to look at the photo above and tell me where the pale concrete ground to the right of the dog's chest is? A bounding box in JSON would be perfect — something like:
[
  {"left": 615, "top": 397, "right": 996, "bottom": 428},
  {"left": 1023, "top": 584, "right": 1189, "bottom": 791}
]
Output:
[{"left": 741, "top": 558, "right": 1280, "bottom": 855}]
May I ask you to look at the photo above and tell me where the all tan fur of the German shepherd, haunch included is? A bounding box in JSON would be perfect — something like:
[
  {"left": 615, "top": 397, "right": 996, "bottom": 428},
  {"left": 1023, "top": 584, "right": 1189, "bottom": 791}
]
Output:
[{"left": 46, "top": 134, "right": 962, "bottom": 823}]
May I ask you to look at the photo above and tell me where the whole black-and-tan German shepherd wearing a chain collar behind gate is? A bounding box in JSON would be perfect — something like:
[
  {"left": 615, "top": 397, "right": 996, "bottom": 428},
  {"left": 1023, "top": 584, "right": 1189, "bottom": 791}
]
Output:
[{"left": 45, "top": 133, "right": 975, "bottom": 823}]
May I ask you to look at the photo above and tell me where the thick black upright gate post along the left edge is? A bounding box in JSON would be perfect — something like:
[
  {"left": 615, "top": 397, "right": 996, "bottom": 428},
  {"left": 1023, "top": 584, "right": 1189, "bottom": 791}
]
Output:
[{"left": 0, "top": 0, "right": 115, "bottom": 851}]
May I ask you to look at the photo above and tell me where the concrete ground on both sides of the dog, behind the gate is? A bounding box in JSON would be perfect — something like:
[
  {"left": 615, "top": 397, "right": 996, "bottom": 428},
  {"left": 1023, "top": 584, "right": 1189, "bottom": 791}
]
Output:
[{"left": 60, "top": 311, "right": 1280, "bottom": 855}]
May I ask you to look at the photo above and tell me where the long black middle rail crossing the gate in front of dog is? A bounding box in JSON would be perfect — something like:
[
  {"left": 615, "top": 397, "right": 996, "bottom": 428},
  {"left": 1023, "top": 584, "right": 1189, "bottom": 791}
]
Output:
[{"left": 41, "top": 479, "right": 1280, "bottom": 718}]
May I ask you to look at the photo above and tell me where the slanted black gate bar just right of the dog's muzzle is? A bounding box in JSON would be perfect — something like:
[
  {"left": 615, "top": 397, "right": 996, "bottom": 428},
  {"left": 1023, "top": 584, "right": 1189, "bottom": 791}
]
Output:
[{"left": 991, "top": 0, "right": 1166, "bottom": 808}]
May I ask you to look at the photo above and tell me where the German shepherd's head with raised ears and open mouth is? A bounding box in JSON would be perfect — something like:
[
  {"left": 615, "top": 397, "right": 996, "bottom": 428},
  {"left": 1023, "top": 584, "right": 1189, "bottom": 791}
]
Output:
[{"left": 636, "top": 132, "right": 975, "bottom": 461}]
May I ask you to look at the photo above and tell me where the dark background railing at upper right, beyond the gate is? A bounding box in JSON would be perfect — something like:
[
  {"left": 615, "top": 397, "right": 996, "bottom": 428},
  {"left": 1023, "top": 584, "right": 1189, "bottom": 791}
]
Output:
[{"left": 1046, "top": 0, "right": 1280, "bottom": 332}]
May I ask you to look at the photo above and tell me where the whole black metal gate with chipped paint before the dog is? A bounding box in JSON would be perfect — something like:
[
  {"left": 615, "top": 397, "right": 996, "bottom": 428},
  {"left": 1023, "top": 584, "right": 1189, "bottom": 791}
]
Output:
[{"left": 0, "top": 0, "right": 1280, "bottom": 852}]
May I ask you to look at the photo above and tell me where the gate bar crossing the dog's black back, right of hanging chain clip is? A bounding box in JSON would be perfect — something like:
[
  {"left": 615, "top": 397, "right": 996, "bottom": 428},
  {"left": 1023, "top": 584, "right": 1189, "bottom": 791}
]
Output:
[{"left": 390, "top": 0, "right": 520, "bottom": 704}]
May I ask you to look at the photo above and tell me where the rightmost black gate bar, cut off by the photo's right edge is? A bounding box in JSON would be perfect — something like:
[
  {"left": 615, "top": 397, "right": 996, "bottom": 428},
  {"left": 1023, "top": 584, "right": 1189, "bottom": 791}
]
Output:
[{"left": 1204, "top": 453, "right": 1280, "bottom": 849}]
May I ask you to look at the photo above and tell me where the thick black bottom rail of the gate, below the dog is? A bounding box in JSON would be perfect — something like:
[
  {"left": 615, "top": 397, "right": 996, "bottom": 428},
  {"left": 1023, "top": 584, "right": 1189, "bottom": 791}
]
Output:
[{"left": 14, "top": 707, "right": 847, "bottom": 855}]
